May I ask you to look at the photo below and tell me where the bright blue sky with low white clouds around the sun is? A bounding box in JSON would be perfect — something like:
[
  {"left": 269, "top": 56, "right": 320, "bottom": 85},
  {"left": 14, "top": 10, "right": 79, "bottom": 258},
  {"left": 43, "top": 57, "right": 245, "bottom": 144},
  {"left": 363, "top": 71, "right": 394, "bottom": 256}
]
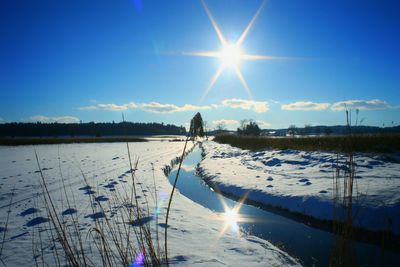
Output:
[{"left": 0, "top": 0, "right": 400, "bottom": 128}]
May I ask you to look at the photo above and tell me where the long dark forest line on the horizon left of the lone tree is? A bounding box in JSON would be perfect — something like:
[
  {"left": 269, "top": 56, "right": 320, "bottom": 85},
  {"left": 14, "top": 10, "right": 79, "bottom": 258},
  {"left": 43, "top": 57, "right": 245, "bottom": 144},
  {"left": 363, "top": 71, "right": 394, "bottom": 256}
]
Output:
[{"left": 0, "top": 122, "right": 186, "bottom": 137}]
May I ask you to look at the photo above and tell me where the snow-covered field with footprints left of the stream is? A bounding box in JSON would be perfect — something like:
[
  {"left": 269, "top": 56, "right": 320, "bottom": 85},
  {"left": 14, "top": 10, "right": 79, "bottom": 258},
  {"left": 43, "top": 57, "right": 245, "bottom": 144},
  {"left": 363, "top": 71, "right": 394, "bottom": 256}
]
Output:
[{"left": 0, "top": 141, "right": 297, "bottom": 266}]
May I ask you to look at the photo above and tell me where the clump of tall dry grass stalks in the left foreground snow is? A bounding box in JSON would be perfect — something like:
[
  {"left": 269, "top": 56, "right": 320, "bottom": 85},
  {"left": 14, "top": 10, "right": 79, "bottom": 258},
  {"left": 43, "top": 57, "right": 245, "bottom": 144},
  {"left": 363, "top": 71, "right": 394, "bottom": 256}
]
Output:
[{"left": 32, "top": 146, "right": 173, "bottom": 266}]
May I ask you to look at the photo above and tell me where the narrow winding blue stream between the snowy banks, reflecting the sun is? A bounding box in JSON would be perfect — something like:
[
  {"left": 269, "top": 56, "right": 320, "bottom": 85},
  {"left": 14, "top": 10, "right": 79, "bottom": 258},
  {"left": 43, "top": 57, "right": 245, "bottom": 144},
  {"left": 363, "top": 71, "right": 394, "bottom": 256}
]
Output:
[{"left": 168, "top": 147, "right": 400, "bottom": 266}]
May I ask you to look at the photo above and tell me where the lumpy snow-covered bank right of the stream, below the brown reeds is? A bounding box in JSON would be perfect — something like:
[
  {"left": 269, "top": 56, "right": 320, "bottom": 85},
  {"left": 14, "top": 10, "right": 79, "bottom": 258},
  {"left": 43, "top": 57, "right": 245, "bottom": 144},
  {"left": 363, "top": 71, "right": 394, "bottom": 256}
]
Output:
[{"left": 200, "top": 141, "right": 400, "bottom": 234}]
